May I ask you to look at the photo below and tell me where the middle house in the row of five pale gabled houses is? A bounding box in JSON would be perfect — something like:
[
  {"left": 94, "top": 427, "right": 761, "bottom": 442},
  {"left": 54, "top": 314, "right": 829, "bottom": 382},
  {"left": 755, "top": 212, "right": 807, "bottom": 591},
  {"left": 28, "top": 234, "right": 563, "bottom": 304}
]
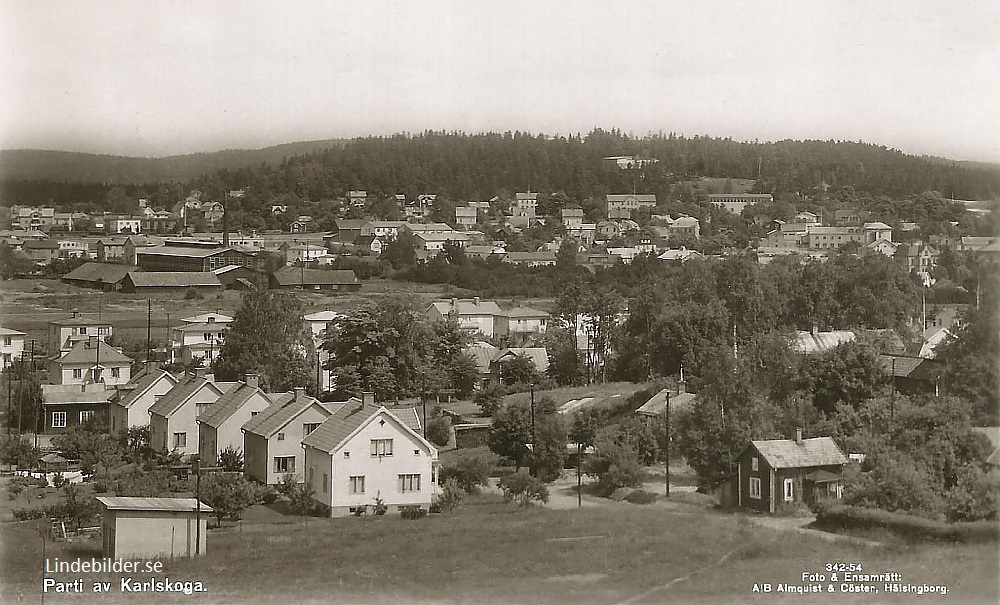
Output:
[{"left": 196, "top": 374, "right": 271, "bottom": 464}]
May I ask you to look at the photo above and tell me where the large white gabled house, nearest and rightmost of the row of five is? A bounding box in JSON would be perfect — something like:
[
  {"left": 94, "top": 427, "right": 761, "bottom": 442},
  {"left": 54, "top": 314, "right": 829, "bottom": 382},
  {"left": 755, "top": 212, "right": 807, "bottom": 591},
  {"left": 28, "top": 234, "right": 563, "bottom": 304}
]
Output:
[{"left": 302, "top": 401, "right": 438, "bottom": 516}]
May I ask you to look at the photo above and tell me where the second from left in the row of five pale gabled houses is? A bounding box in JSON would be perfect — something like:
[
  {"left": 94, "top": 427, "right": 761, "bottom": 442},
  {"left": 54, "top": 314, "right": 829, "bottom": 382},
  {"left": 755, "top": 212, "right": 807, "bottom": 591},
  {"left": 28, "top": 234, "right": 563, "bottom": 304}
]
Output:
[{"left": 149, "top": 377, "right": 233, "bottom": 454}]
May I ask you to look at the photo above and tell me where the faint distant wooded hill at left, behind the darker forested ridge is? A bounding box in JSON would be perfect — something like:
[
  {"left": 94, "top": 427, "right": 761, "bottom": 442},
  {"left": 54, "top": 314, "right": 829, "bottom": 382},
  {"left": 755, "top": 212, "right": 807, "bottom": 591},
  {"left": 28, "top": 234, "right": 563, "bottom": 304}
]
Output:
[{"left": 0, "top": 139, "right": 345, "bottom": 184}]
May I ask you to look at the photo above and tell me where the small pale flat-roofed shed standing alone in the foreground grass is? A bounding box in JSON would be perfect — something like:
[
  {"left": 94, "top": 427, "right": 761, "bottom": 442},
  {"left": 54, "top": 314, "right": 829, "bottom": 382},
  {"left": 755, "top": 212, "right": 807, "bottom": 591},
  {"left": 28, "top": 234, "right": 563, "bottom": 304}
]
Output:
[{"left": 97, "top": 496, "right": 212, "bottom": 559}]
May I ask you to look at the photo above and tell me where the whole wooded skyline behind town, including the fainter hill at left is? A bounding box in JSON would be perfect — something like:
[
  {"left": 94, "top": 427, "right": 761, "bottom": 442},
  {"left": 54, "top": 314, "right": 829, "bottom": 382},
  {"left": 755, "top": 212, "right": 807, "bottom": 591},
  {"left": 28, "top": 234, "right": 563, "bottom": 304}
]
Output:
[{"left": 0, "top": 130, "right": 1000, "bottom": 203}]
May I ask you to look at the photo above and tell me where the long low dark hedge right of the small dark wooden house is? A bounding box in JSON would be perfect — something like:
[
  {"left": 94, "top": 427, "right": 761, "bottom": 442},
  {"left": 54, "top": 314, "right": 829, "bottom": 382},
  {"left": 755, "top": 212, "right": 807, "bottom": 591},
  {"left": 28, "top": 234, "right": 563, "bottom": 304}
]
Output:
[{"left": 815, "top": 504, "right": 1000, "bottom": 543}]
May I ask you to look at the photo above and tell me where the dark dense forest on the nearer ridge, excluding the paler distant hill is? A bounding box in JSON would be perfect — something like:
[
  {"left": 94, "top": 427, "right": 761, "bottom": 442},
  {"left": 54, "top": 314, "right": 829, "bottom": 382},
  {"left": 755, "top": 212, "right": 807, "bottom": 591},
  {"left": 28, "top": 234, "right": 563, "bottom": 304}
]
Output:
[{"left": 0, "top": 129, "right": 1000, "bottom": 215}]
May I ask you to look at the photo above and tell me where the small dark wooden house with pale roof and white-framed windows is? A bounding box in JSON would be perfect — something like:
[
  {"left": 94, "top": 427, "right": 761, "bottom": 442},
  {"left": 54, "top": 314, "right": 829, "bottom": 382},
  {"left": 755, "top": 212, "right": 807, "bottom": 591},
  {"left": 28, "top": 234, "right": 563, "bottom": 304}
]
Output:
[{"left": 735, "top": 431, "right": 848, "bottom": 513}]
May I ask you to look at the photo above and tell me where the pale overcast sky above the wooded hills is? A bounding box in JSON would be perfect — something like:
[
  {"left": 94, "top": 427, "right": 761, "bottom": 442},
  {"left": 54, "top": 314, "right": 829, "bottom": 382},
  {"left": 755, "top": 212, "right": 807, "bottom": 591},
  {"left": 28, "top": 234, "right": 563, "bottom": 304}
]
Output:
[{"left": 0, "top": 0, "right": 1000, "bottom": 161}]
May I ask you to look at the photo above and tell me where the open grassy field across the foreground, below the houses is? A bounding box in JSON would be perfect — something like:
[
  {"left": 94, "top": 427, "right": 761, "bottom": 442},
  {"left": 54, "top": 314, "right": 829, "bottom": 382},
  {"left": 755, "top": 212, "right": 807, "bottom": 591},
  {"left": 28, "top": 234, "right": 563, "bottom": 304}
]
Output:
[{"left": 0, "top": 504, "right": 1000, "bottom": 603}]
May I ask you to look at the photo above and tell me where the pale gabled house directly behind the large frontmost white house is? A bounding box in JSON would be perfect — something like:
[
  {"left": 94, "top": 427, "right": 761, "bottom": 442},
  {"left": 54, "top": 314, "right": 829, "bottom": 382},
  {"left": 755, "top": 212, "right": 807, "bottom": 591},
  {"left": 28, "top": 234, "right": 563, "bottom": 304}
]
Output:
[{"left": 241, "top": 388, "right": 338, "bottom": 487}]
